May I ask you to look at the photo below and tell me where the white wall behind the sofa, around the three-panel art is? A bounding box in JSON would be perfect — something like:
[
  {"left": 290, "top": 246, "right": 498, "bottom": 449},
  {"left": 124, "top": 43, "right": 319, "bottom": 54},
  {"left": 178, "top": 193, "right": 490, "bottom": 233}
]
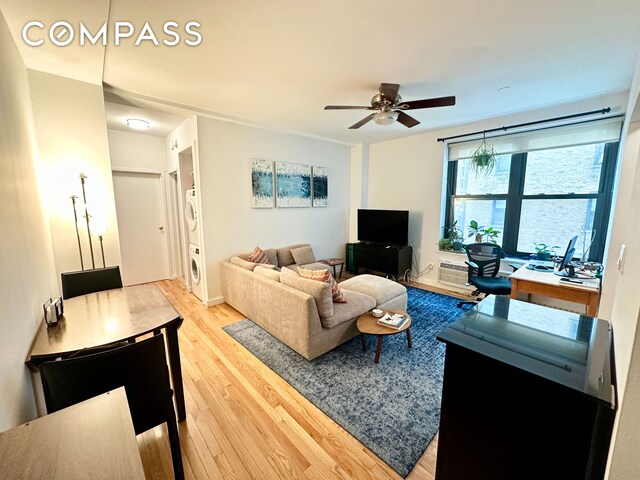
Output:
[{"left": 197, "top": 117, "right": 350, "bottom": 303}]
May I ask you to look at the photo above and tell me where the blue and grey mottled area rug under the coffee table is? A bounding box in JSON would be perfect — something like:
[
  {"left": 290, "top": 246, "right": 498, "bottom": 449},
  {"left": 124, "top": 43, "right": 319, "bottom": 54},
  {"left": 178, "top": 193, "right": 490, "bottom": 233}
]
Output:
[{"left": 224, "top": 287, "right": 466, "bottom": 477}]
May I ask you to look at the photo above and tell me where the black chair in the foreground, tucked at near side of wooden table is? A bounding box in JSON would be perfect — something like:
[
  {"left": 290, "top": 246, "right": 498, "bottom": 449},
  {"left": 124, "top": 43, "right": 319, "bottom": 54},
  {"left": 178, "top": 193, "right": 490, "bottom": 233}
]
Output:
[{"left": 40, "top": 335, "right": 184, "bottom": 480}]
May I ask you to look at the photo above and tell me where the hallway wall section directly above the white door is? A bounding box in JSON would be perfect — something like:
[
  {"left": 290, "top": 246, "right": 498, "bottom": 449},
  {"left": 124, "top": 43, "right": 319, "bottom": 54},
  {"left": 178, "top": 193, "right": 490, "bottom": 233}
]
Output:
[{"left": 107, "top": 130, "right": 169, "bottom": 172}]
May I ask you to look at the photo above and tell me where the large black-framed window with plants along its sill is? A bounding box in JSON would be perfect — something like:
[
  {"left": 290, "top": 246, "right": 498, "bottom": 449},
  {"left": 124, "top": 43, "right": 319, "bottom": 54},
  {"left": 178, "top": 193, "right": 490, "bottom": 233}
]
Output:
[{"left": 445, "top": 122, "right": 620, "bottom": 261}]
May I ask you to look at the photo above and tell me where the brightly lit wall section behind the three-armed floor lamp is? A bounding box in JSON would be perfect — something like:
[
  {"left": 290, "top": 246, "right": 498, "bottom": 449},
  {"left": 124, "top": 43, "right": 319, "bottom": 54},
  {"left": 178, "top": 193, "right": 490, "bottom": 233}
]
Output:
[{"left": 28, "top": 70, "right": 120, "bottom": 278}]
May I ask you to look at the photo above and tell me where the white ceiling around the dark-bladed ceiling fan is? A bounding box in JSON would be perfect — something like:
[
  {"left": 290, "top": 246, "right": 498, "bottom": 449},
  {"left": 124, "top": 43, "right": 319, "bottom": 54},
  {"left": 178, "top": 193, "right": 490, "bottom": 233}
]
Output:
[{"left": 0, "top": 0, "right": 640, "bottom": 143}]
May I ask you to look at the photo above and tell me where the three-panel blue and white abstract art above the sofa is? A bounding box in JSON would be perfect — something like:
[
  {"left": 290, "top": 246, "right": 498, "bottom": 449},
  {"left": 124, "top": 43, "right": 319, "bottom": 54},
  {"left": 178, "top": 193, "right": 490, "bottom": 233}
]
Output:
[{"left": 251, "top": 158, "right": 329, "bottom": 208}]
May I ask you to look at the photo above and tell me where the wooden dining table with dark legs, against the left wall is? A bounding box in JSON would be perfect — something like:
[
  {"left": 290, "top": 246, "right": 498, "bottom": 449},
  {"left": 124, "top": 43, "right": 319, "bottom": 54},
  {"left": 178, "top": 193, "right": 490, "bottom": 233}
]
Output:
[{"left": 25, "top": 284, "right": 186, "bottom": 421}]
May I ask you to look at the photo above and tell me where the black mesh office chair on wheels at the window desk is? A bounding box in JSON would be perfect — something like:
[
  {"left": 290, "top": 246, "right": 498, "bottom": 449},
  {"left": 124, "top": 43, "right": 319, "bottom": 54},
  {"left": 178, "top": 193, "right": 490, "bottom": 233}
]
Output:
[{"left": 458, "top": 243, "right": 518, "bottom": 307}]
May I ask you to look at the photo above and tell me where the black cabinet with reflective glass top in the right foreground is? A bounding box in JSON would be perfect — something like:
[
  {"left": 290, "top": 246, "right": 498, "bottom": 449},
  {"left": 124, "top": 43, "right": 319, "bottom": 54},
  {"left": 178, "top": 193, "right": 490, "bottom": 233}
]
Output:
[{"left": 436, "top": 296, "right": 615, "bottom": 480}]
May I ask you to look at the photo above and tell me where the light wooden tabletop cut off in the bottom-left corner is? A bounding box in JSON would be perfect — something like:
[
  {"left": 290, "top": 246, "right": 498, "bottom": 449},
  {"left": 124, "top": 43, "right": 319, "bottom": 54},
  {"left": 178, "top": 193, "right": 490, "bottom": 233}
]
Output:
[{"left": 0, "top": 387, "right": 145, "bottom": 480}]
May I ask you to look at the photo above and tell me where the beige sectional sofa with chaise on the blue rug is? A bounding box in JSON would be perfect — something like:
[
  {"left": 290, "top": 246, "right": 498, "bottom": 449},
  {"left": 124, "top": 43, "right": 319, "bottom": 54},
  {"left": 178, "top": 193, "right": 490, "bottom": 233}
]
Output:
[{"left": 221, "top": 245, "right": 407, "bottom": 360}]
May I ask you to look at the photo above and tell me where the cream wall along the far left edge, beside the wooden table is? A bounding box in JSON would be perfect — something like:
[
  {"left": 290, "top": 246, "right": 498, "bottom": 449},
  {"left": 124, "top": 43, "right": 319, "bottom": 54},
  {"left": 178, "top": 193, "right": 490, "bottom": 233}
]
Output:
[{"left": 0, "top": 12, "right": 58, "bottom": 431}]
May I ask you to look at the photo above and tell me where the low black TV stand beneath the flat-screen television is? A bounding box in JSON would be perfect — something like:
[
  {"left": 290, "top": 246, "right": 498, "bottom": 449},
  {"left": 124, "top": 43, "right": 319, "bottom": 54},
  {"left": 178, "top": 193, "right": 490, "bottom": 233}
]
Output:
[{"left": 353, "top": 242, "right": 413, "bottom": 276}]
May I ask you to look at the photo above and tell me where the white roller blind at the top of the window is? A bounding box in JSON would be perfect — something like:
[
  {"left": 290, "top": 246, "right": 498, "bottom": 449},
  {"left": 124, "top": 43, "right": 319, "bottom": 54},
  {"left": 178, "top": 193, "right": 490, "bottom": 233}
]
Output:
[{"left": 448, "top": 117, "right": 622, "bottom": 161}]
